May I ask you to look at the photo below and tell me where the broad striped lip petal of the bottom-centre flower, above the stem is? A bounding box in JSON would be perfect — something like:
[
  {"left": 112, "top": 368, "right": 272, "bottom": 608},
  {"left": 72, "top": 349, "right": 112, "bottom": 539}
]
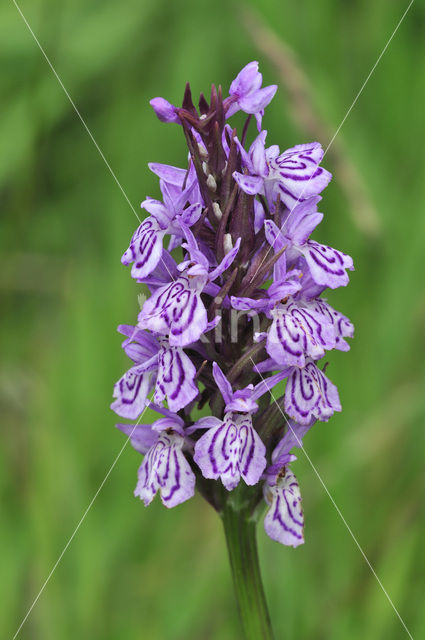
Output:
[{"left": 194, "top": 412, "right": 266, "bottom": 491}]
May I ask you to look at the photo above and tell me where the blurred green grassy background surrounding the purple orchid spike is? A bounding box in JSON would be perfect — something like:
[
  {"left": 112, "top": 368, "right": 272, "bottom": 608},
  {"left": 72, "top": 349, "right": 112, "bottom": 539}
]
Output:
[{"left": 0, "top": 0, "right": 425, "bottom": 640}]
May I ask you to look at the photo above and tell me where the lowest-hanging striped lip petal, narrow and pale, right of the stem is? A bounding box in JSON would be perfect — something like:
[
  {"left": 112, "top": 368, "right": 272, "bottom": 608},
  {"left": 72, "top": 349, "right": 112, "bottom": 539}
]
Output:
[{"left": 264, "top": 467, "right": 304, "bottom": 547}]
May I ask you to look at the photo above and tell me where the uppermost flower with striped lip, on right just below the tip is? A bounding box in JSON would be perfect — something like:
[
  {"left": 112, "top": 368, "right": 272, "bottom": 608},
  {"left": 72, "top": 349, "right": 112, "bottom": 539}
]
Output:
[{"left": 233, "top": 131, "right": 332, "bottom": 209}]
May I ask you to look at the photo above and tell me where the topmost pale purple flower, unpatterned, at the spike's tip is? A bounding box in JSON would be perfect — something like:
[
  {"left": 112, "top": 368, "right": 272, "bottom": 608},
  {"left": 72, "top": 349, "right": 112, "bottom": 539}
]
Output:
[{"left": 224, "top": 61, "right": 277, "bottom": 131}]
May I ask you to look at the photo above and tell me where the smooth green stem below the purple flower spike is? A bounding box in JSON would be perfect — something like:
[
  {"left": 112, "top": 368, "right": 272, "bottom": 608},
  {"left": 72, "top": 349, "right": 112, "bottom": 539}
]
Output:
[{"left": 221, "top": 501, "right": 273, "bottom": 640}]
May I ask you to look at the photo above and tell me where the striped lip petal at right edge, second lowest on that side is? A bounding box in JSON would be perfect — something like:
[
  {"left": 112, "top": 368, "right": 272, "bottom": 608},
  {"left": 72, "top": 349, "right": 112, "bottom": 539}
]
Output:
[{"left": 285, "top": 360, "right": 341, "bottom": 424}]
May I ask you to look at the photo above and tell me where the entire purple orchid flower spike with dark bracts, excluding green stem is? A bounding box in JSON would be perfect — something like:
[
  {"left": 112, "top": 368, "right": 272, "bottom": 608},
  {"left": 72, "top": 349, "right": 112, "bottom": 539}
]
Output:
[{"left": 112, "top": 62, "right": 353, "bottom": 546}]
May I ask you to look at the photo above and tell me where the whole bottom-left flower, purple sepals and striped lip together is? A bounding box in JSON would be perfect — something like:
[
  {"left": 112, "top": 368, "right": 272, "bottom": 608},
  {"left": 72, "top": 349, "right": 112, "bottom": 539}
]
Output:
[{"left": 117, "top": 411, "right": 195, "bottom": 508}]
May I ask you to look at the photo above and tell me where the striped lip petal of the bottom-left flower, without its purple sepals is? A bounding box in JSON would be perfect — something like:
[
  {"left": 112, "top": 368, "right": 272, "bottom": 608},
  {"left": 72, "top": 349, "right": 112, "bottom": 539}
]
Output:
[{"left": 134, "top": 431, "right": 195, "bottom": 508}]
